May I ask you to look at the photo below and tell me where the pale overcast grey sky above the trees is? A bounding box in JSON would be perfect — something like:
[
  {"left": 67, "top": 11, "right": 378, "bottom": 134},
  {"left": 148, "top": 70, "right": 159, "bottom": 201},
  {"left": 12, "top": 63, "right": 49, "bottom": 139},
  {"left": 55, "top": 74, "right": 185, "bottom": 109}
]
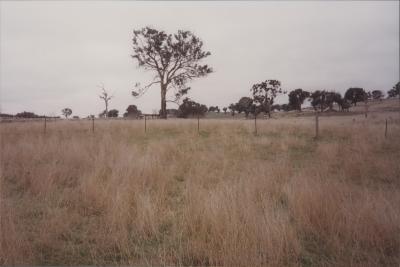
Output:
[{"left": 0, "top": 1, "right": 400, "bottom": 117}]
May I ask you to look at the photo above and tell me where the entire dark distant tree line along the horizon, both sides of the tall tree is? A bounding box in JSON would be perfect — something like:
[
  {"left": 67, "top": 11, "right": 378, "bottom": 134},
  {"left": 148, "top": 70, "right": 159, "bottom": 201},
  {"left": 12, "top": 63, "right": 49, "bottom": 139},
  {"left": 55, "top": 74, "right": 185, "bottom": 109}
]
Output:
[{"left": 0, "top": 80, "right": 400, "bottom": 119}]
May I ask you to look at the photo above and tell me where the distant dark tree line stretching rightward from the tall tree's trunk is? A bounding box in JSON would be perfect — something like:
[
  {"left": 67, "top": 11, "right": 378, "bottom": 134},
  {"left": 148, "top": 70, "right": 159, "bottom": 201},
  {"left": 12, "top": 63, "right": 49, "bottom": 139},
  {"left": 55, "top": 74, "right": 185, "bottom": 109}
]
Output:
[{"left": 153, "top": 80, "right": 399, "bottom": 118}]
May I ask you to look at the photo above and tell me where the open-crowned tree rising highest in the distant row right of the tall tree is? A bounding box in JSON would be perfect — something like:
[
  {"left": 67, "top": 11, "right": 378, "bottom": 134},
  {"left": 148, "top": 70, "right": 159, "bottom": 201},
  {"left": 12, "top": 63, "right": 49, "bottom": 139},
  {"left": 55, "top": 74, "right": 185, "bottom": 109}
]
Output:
[{"left": 250, "top": 80, "right": 285, "bottom": 117}]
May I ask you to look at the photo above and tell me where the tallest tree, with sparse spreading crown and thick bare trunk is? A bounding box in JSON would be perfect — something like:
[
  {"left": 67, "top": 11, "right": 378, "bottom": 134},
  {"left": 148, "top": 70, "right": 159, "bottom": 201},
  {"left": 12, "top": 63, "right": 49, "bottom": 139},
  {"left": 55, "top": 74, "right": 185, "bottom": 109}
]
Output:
[{"left": 132, "top": 27, "right": 212, "bottom": 118}]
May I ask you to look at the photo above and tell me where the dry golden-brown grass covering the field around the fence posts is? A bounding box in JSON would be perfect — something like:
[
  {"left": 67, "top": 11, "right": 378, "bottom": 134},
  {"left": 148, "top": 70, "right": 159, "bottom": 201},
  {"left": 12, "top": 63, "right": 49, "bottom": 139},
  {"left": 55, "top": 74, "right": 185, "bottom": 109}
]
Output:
[{"left": 0, "top": 114, "right": 400, "bottom": 266}]
